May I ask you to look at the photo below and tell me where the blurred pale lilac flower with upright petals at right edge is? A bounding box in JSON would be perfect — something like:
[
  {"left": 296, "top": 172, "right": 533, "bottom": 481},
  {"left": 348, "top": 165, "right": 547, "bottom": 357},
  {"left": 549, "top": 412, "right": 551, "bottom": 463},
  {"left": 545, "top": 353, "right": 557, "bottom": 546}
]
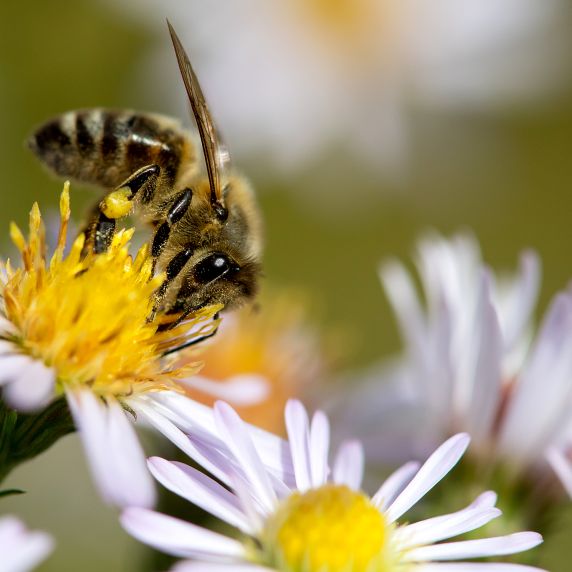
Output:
[{"left": 330, "top": 236, "right": 572, "bottom": 495}]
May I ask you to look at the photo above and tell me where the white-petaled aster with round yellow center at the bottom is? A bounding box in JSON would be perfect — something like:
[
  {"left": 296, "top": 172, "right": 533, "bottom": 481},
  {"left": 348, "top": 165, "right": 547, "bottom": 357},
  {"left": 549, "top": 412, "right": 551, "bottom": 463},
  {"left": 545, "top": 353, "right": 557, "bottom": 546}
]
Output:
[{"left": 121, "top": 401, "right": 542, "bottom": 572}]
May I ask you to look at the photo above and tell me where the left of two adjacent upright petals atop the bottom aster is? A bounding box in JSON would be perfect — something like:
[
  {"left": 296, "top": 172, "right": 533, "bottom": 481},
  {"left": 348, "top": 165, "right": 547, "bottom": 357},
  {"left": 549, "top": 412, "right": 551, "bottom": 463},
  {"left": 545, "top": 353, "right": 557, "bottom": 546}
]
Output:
[{"left": 285, "top": 399, "right": 312, "bottom": 492}]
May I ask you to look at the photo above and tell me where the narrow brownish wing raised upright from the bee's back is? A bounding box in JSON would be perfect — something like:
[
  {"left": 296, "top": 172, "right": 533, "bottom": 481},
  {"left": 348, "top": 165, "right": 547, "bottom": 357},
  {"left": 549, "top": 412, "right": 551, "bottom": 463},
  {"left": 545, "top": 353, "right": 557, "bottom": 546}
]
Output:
[{"left": 167, "top": 21, "right": 230, "bottom": 206}]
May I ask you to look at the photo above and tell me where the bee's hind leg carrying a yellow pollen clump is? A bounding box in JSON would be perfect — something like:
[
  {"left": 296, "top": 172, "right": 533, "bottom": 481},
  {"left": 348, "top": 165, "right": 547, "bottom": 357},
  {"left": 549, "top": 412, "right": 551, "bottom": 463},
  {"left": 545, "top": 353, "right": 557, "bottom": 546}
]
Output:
[{"left": 84, "top": 165, "right": 161, "bottom": 254}]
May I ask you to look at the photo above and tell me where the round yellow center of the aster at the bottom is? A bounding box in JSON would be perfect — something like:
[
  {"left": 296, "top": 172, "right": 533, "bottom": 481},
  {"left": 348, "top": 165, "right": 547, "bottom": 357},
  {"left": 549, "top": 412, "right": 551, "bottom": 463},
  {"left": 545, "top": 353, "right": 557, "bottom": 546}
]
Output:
[{"left": 263, "top": 485, "right": 391, "bottom": 572}]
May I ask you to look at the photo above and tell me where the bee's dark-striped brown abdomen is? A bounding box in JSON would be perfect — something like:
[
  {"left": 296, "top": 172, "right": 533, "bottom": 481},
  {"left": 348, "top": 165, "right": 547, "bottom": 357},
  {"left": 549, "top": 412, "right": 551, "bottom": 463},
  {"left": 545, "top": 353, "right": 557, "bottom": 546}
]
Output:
[{"left": 30, "top": 109, "right": 194, "bottom": 192}]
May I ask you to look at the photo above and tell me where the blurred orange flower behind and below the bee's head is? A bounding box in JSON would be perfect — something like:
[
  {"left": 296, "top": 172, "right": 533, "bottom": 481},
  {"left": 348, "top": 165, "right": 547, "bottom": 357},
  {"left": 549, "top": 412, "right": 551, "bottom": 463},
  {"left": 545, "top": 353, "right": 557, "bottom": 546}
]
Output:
[{"left": 187, "top": 292, "right": 326, "bottom": 434}]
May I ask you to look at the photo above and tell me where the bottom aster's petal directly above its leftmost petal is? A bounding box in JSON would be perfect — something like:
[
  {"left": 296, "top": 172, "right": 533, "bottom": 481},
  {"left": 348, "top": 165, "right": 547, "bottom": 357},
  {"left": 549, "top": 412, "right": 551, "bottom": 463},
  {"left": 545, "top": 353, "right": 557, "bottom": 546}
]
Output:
[{"left": 148, "top": 457, "right": 253, "bottom": 534}]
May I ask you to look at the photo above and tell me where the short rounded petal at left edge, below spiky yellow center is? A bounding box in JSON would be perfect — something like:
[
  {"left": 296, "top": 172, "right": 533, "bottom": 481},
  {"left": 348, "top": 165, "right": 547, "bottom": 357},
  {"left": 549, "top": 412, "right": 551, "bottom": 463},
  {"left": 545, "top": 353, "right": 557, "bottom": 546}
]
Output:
[{"left": 0, "top": 362, "right": 56, "bottom": 412}]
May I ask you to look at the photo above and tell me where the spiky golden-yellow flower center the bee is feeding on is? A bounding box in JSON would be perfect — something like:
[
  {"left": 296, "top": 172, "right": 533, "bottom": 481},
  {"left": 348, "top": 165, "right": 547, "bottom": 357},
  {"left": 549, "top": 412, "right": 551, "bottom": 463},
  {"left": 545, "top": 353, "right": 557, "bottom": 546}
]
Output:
[{"left": 0, "top": 185, "right": 220, "bottom": 397}]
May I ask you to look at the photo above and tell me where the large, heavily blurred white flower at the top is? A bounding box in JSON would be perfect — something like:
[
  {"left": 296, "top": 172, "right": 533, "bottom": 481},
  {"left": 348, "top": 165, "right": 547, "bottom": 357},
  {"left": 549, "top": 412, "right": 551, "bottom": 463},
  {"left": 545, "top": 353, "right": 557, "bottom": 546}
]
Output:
[{"left": 101, "top": 0, "right": 570, "bottom": 179}]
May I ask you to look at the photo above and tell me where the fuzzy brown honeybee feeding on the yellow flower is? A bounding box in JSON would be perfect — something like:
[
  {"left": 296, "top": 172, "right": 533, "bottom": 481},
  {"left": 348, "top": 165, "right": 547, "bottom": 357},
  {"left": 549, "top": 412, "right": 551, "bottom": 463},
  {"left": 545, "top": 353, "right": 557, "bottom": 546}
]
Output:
[{"left": 29, "top": 22, "right": 261, "bottom": 336}]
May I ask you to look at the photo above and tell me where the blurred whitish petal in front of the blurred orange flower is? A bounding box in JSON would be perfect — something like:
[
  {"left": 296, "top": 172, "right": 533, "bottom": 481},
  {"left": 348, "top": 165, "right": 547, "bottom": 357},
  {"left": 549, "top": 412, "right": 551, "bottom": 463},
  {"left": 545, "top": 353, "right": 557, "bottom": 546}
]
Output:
[{"left": 179, "top": 373, "right": 270, "bottom": 407}]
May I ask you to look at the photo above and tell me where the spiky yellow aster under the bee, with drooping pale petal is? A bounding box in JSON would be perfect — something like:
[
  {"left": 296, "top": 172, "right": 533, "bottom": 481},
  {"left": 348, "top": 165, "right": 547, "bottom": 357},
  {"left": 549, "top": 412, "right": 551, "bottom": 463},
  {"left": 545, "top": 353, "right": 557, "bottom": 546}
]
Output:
[{"left": 0, "top": 185, "right": 260, "bottom": 506}]
